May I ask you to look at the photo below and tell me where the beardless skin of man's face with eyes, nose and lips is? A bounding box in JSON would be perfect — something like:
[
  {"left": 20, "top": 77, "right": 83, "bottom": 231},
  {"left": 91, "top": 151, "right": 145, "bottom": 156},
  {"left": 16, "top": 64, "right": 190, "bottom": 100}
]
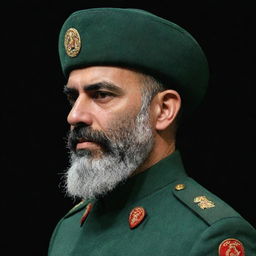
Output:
[{"left": 65, "top": 67, "right": 142, "bottom": 156}]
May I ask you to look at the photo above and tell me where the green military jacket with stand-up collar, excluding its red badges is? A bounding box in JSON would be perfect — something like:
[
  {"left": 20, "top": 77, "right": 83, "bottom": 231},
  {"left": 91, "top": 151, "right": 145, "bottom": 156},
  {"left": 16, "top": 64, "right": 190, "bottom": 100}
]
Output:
[{"left": 49, "top": 152, "right": 256, "bottom": 256}]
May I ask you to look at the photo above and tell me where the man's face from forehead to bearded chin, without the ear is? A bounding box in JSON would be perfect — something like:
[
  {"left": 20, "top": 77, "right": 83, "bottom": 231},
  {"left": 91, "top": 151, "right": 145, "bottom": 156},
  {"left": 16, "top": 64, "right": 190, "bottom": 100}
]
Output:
[{"left": 64, "top": 66, "right": 154, "bottom": 200}]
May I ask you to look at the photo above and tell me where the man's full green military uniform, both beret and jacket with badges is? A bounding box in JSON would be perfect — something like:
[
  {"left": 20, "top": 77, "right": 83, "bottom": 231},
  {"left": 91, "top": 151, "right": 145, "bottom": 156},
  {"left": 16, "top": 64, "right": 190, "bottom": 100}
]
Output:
[{"left": 49, "top": 8, "right": 256, "bottom": 256}]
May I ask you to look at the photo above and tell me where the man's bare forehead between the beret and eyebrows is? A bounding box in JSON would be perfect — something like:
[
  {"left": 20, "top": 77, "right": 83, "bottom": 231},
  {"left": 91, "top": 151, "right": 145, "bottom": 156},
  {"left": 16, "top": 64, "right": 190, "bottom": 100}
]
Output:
[{"left": 67, "top": 66, "right": 144, "bottom": 92}]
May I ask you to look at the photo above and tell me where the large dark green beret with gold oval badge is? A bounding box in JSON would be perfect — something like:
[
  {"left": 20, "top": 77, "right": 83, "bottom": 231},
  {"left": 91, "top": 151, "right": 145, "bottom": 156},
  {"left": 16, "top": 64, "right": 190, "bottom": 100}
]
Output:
[{"left": 59, "top": 8, "right": 209, "bottom": 118}]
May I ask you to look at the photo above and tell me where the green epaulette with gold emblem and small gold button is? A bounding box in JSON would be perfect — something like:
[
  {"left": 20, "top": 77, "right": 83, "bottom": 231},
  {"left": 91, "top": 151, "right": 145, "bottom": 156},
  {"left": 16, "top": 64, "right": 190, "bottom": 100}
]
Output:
[{"left": 173, "top": 177, "right": 240, "bottom": 225}]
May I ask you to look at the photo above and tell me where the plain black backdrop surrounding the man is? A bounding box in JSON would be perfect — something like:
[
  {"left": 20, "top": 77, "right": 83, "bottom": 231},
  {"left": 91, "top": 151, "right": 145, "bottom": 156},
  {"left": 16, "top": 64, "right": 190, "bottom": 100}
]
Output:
[{"left": 1, "top": 0, "right": 256, "bottom": 255}]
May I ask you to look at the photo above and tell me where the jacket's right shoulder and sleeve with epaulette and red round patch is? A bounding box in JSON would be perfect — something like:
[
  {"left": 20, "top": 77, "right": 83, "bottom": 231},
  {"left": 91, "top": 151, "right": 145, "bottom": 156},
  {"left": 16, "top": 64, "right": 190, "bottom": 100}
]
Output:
[{"left": 172, "top": 177, "right": 256, "bottom": 256}]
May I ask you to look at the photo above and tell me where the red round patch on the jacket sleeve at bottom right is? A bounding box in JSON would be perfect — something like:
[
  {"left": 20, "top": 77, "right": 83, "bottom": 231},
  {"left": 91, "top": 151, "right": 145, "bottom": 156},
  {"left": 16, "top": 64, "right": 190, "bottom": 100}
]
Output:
[{"left": 219, "top": 238, "right": 245, "bottom": 256}]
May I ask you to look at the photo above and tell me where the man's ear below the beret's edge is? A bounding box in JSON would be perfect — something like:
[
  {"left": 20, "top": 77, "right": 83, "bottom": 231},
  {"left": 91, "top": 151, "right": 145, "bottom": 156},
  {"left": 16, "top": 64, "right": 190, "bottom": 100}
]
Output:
[{"left": 155, "top": 90, "right": 181, "bottom": 130}]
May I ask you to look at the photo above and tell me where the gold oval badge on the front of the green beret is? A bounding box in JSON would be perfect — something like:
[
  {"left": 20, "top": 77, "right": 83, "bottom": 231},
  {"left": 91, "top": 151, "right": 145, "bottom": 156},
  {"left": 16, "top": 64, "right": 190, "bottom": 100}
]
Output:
[{"left": 64, "top": 28, "right": 81, "bottom": 57}]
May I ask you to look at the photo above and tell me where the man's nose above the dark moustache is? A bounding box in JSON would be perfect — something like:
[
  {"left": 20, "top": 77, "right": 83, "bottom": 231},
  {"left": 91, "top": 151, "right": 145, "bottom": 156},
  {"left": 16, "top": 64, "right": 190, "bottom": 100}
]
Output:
[{"left": 67, "top": 95, "right": 92, "bottom": 126}]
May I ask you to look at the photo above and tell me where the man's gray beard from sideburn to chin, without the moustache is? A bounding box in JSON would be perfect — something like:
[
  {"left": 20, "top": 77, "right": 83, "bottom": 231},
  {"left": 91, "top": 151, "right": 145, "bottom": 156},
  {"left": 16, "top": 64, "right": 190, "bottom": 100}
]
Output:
[{"left": 65, "top": 109, "right": 154, "bottom": 200}]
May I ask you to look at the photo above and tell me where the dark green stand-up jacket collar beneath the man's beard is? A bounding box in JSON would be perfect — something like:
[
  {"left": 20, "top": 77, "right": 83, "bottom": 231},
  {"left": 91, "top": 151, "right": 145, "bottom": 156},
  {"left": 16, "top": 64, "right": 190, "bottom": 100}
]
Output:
[{"left": 99, "top": 151, "right": 186, "bottom": 209}]
